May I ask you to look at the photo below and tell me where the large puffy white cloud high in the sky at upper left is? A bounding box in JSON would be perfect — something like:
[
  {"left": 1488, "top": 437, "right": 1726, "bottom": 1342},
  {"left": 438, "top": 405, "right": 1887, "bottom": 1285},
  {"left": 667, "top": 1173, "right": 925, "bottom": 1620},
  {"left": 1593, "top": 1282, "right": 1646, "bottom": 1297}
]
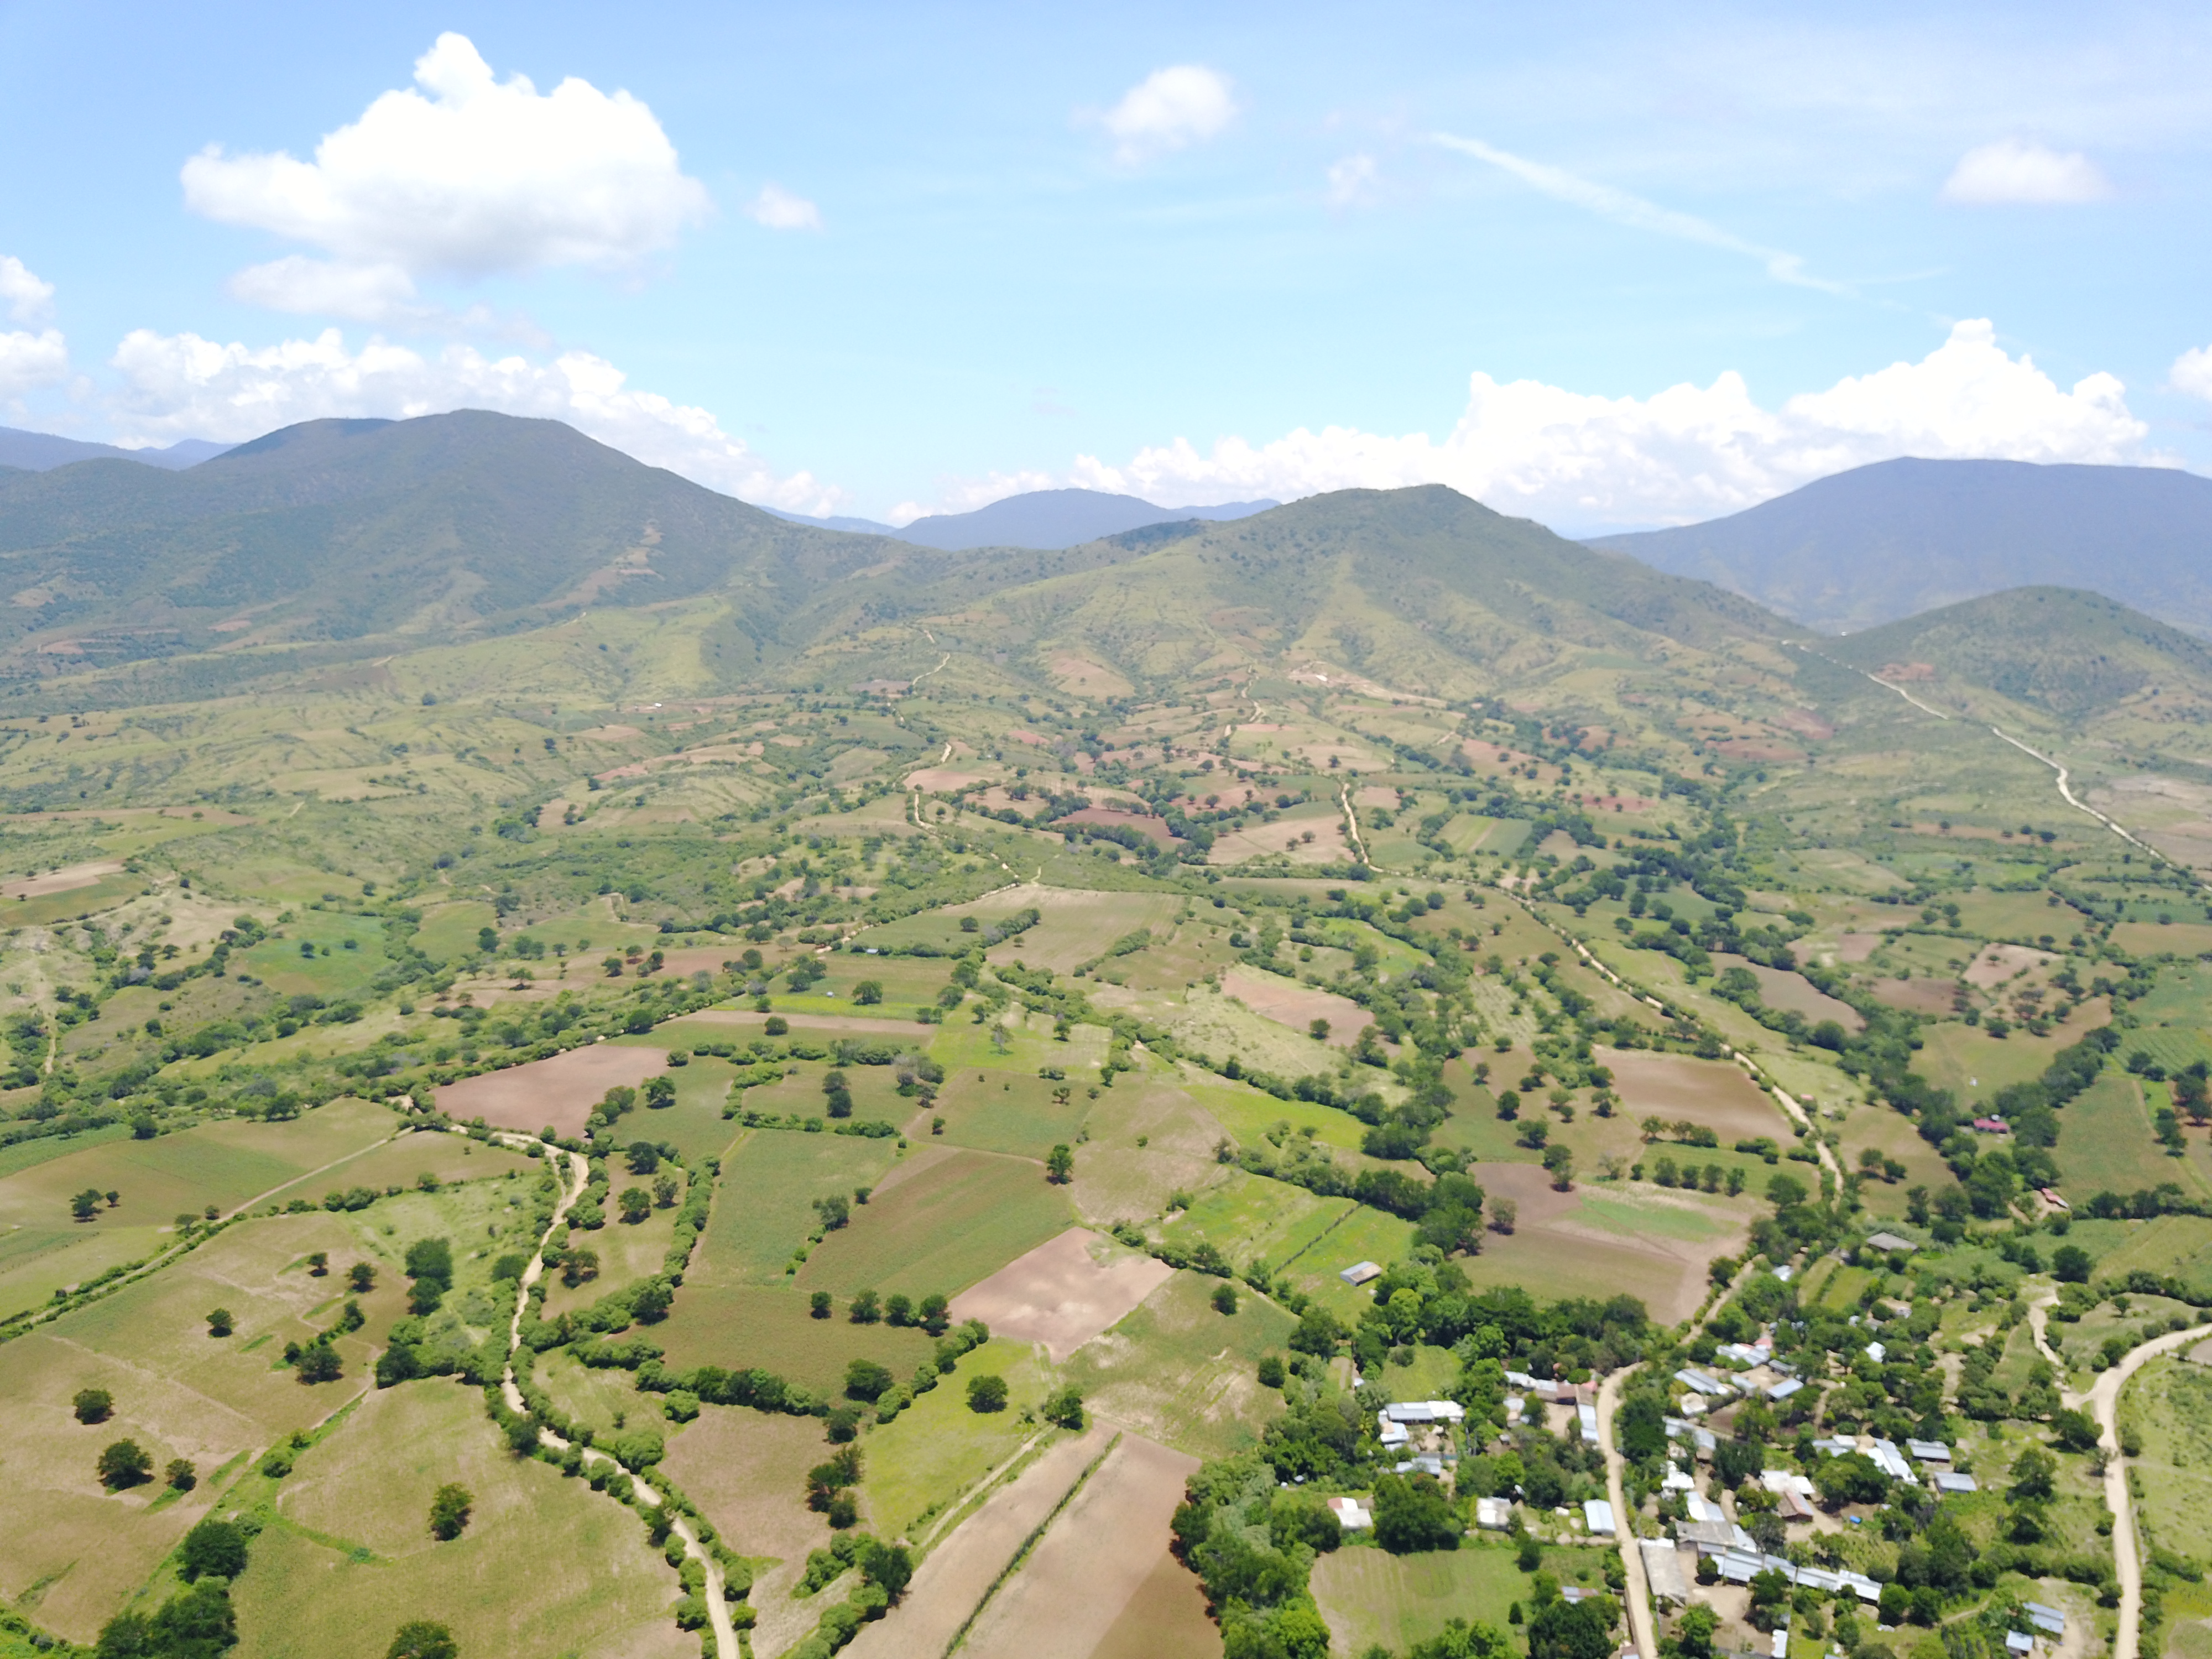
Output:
[{"left": 184, "top": 33, "right": 708, "bottom": 299}]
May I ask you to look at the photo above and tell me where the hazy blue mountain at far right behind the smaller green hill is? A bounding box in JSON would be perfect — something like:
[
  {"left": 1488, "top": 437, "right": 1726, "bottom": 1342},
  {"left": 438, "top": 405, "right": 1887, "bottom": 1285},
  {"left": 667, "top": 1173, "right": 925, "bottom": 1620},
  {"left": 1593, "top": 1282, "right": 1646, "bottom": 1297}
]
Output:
[{"left": 1588, "top": 460, "right": 2212, "bottom": 635}]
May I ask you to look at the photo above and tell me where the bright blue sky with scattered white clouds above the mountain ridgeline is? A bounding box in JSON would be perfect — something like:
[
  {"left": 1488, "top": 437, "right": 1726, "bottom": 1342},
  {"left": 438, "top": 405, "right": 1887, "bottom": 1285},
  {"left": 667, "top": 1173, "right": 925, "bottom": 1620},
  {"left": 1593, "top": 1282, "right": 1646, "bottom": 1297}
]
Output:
[{"left": 0, "top": 0, "right": 2212, "bottom": 529}]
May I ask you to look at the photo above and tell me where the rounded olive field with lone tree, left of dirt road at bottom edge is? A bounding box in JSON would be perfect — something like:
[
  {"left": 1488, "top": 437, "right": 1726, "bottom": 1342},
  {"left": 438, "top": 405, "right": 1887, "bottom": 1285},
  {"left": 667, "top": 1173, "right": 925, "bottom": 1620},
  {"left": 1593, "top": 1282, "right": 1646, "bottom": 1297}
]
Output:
[{"left": 237, "top": 1380, "right": 699, "bottom": 1659}]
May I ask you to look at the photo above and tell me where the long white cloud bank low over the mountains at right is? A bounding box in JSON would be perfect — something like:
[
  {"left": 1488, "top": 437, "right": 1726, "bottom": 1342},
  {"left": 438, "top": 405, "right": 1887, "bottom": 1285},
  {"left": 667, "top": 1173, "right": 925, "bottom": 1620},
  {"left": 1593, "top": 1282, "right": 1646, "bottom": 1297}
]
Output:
[{"left": 1064, "top": 321, "right": 2150, "bottom": 526}]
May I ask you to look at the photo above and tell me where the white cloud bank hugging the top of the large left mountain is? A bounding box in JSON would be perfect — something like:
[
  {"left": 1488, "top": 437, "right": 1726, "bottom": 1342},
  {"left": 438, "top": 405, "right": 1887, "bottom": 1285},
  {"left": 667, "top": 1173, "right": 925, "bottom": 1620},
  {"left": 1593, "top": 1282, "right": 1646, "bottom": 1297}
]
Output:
[{"left": 104, "top": 330, "right": 845, "bottom": 513}]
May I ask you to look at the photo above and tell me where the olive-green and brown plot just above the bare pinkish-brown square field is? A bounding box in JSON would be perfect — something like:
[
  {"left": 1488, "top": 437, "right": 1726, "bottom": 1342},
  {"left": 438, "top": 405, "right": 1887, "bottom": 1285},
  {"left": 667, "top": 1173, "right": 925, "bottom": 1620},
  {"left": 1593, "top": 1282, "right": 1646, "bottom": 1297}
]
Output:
[{"left": 799, "top": 1146, "right": 1075, "bottom": 1296}]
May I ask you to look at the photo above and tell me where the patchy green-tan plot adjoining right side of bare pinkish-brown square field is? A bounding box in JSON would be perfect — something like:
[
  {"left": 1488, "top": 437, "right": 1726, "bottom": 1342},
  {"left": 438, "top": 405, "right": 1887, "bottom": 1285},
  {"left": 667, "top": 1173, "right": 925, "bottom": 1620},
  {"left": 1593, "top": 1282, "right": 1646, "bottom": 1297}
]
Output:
[{"left": 1062, "top": 1272, "right": 1296, "bottom": 1458}]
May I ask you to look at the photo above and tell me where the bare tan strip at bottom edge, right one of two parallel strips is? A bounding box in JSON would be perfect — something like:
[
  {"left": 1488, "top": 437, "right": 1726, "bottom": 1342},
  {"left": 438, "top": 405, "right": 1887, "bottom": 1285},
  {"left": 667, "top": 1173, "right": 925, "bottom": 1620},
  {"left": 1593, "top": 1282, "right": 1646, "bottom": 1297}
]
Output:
[{"left": 967, "top": 1436, "right": 1212, "bottom": 1659}]
